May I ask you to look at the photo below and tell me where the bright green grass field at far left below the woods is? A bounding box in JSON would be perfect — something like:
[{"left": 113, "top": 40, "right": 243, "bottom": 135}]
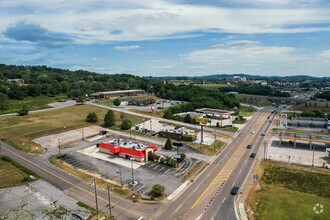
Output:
[{"left": 0, "top": 94, "right": 68, "bottom": 115}]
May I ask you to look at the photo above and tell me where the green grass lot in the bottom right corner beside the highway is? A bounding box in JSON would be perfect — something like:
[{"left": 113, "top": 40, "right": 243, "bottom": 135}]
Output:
[{"left": 247, "top": 161, "right": 330, "bottom": 220}]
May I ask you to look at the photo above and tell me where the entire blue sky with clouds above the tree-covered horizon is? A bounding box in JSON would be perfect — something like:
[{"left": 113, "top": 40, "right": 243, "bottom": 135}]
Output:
[{"left": 0, "top": 0, "right": 330, "bottom": 77}]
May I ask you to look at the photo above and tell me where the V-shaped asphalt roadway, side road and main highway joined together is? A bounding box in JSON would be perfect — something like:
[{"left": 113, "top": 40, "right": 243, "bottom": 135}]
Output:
[{"left": 2, "top": 108, "right": 272, "bottom": 219}]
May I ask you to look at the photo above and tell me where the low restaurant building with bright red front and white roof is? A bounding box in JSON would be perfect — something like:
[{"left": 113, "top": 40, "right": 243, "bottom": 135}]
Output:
[{"left": 99, "top": 138, "right": 157, "bottom": 162}]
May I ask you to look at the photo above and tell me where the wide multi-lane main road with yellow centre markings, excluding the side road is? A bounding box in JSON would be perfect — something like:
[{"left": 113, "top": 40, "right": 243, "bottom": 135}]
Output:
[{"left": 156, "top": 109, "right": 273, "bottom": 220}]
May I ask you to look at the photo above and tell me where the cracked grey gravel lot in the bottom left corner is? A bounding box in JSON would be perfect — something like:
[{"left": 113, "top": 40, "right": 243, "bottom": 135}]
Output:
[{"left": 0, "top": 180, "right": 90, "bottom": 220}]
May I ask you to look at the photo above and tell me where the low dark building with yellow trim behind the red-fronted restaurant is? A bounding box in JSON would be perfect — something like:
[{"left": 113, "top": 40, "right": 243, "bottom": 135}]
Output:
[{"left": 159, "top": 129, "right": 198, "bottom": 142}]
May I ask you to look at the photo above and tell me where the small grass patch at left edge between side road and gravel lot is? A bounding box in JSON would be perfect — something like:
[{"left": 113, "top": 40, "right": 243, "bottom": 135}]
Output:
[{"left": 0, "top": 157, "right": 38, "bottom": 189}]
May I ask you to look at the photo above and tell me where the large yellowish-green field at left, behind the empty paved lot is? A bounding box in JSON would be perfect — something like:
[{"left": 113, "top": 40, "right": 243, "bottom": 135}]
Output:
[{"left": 0, "top": 105, "right": 141, "bottom": 153}]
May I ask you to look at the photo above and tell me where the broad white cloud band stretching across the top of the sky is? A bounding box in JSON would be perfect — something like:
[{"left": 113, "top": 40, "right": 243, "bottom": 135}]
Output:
[{"left": 0, "top": 0, "right": 330, "bottom": 43}]
